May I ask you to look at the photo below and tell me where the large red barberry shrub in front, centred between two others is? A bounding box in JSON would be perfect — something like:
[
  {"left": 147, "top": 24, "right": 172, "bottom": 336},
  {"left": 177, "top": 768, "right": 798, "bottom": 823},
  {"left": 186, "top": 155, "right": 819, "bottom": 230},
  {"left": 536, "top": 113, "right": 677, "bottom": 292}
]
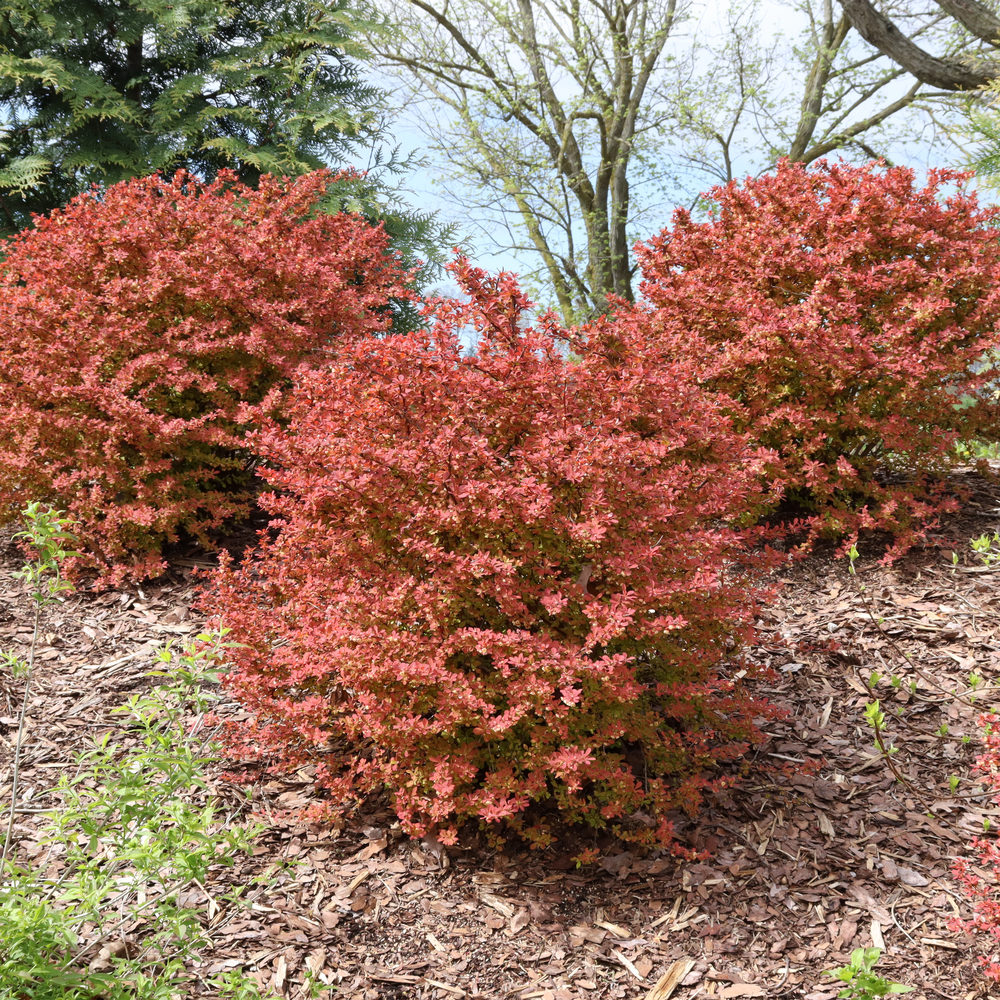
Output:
[{"left": 211, "top": 261, "right": 768, "bottom": 844}]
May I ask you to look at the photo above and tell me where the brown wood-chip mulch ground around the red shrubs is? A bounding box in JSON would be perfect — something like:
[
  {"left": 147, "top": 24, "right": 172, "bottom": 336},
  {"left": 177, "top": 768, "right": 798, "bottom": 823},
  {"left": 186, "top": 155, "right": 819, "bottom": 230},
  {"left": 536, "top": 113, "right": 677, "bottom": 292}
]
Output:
[{"left": 0, "top": 473, "right": 1000, "bottom": 1000}]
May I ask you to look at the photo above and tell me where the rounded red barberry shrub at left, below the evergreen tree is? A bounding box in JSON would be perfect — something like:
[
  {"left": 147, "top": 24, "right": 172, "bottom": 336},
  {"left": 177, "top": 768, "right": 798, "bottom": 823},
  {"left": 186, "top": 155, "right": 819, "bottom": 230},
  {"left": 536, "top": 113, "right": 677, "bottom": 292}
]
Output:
[{"left": 0, "top": 171, "right": 406, "bottom": 580}]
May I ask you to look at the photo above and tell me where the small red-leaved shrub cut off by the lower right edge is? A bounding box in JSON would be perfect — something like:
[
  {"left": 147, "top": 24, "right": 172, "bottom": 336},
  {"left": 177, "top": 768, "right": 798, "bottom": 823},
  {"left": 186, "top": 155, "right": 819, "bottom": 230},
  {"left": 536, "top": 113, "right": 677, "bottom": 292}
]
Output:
[{"left": 951, "top": 712, "right": 1000, "bottom": 982}]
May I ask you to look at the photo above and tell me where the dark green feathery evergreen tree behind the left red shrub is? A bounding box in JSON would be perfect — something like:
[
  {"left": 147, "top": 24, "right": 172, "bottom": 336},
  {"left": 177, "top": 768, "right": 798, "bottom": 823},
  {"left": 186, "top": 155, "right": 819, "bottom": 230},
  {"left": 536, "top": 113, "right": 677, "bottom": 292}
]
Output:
[{"left": 0, "top": 0, "right": 381, "bottom": 231}]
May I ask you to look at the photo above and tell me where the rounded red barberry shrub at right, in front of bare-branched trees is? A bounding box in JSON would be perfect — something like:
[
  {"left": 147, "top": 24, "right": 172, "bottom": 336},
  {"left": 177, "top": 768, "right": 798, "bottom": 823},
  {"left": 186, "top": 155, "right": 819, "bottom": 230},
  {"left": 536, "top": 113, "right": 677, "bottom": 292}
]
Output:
[{"left": 631, "top": 161, "right": 1000, "bottom": 560}]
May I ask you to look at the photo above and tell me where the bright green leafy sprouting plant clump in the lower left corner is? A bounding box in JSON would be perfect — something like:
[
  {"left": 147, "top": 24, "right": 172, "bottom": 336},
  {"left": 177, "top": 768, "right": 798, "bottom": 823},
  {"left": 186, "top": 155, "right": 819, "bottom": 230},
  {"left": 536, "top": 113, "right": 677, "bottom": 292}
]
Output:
[{"left": 0, "top": 504, "right": 259, "bottom": 1000}]
